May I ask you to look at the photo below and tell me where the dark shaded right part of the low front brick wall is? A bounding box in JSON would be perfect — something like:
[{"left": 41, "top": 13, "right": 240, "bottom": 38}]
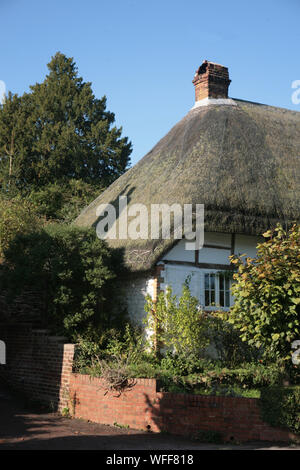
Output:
[{"left": 144, "top": 392, "right": 298, "bottom": 443}]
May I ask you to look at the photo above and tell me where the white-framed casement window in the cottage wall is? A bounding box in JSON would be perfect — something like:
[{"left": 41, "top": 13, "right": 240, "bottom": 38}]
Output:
[{"left": 204, "top": 273, "right": 230, "bottom": 308}]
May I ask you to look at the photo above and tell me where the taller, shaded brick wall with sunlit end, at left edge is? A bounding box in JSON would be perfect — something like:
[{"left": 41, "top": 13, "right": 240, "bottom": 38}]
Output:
[{"left": 0, "top": 324, "right": 74, "bottom": 410}]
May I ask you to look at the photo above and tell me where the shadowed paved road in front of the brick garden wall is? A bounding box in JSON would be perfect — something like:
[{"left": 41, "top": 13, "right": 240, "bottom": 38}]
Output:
[{"left": 0, "top": 384, "right": 300, "bottom": 451}]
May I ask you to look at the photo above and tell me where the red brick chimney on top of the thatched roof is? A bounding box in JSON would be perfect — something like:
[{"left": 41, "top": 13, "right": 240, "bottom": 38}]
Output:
[{"left": 193, "top": 60, "right": 231, "bottom": 102}]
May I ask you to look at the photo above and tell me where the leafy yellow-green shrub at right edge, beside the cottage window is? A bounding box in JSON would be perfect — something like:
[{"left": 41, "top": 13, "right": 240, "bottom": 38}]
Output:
[{"left": 229, "top": 225, "right": 300, "bottom": 361}]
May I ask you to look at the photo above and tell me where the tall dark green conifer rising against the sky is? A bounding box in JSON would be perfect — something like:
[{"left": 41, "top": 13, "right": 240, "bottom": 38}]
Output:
[{"left": 0, "top": 53, "right": 131, "bottom": 192}]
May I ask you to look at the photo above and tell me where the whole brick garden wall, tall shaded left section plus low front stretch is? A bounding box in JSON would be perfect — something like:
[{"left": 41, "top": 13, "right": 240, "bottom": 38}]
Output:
[{"left": 0, "top": 324, "right": 294, "bottom": 442}]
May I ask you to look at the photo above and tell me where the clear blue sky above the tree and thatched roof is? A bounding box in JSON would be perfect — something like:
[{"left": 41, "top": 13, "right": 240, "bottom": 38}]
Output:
[{"left": 0, "top": 0, "right": 300, "bottom": 163}]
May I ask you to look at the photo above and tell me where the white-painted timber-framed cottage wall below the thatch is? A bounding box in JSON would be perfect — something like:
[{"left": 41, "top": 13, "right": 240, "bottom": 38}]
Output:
[{"left": 123, "top": 232, "right": 262, "bottom": 326}]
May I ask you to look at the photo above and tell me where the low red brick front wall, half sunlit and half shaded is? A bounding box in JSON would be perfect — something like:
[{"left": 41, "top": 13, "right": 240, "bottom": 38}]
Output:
[{"left": 69, "top": 374, "right": 293, "bottom": 442}]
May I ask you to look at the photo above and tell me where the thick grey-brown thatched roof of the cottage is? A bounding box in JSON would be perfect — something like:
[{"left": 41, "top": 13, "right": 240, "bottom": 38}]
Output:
[{"left": 76, "top": 100, "right": 300, "bottom": 270}]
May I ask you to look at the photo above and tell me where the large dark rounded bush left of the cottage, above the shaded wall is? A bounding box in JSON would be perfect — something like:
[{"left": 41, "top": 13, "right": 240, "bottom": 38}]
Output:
[{"left": 0, "top": 224, "right": 126, "bottom": 340}]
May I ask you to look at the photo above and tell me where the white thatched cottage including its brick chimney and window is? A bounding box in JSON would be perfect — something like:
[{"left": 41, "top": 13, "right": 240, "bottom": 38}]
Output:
[{"left": 77, "top": 61, "right": 300, "bottom": 324}]
